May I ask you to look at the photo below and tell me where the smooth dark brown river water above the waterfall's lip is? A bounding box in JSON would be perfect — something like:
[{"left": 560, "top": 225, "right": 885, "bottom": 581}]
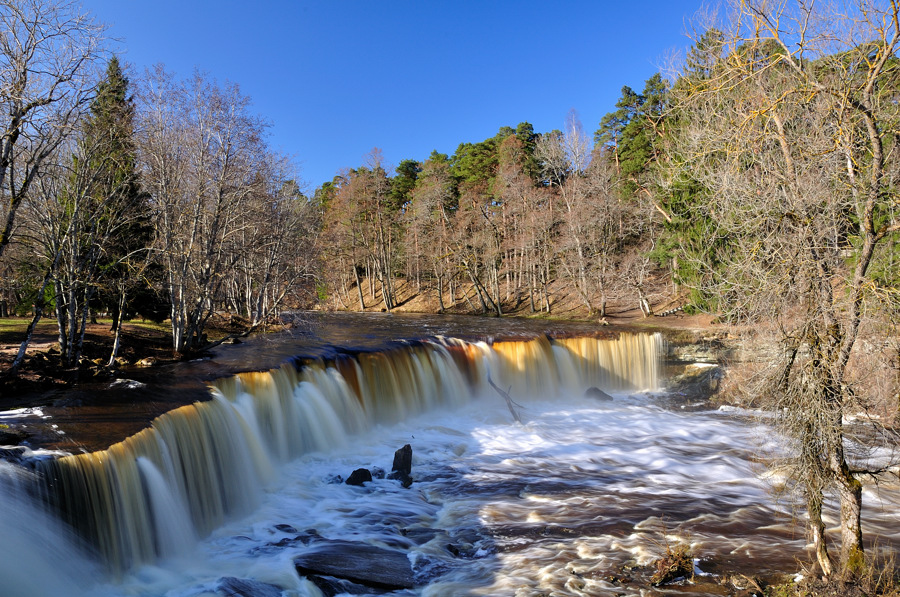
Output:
[{"left": 22, "top": 312, "right": 615, "bottom": 451}]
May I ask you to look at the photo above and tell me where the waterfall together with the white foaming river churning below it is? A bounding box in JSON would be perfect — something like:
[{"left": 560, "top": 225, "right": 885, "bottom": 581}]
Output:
[{"left": 0, "top": 322, "right": 898, "bottom": 597}]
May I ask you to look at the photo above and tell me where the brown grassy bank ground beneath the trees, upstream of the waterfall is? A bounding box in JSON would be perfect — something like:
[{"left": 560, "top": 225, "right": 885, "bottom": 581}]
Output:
[{"left": 0, "top": 279, "right": 716, "bottom": 411}]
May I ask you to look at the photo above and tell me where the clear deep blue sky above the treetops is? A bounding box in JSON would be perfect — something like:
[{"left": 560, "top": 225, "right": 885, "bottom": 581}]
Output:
[{"left": 83, "top": 0, "right": 700, "bottom": 190}]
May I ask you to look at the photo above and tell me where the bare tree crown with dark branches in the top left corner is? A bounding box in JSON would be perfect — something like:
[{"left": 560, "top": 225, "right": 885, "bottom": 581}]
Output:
[{"left": 0, "top": 0, "right": 104, "bottom": 257}]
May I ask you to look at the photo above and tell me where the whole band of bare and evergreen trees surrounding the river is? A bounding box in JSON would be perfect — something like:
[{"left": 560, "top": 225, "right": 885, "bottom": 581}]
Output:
[{"left": 0, "top": 0, "right": 900, "bottom": 575}]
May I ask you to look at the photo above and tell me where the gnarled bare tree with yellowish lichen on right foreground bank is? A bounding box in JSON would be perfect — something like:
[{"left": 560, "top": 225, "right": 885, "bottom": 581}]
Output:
[{"left": 673, "top": 0, "right": 900, "bottom": 575}]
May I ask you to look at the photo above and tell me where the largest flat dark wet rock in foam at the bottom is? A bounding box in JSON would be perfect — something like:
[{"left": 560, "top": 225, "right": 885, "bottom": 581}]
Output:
[{"left": 294, "top": 541, "right": 416, "bottom": 591}]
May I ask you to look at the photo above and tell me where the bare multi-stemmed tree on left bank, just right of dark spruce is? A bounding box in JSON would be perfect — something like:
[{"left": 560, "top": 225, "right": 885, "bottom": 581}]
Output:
[{"left": 138, "top": 67, "right": 269, "bottom": 352}]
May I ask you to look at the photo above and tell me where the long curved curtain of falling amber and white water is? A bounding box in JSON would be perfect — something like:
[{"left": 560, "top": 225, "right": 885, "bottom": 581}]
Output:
[{"left": 31, "top": 333, "right": 662, "bottom": 572}]
